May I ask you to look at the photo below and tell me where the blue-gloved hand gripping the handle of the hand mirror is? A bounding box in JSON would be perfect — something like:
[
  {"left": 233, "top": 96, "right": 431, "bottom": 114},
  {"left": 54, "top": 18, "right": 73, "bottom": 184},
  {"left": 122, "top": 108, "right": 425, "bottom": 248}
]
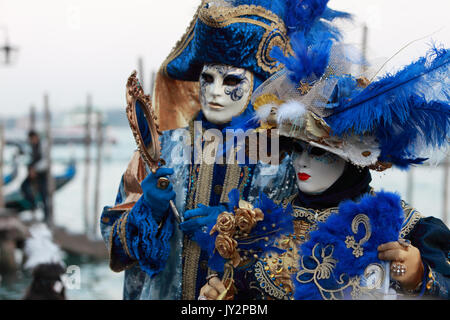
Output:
[{"left": 141, "top": 168, "right": 176, "bottom": 222}]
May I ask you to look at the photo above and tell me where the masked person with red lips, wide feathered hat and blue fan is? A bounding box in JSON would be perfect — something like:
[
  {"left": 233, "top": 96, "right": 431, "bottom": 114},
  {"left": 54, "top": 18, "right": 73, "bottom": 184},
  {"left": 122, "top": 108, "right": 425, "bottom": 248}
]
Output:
[{"left": 195, "top": 33, "right": 450, "bottom": 300}]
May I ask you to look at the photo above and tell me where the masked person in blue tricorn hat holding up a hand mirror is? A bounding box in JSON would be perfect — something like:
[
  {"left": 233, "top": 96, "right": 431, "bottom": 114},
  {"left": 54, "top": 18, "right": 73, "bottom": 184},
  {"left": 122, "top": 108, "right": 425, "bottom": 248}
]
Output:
[{"left": 101, "top": 0, "right": 348, "bottom": 299}]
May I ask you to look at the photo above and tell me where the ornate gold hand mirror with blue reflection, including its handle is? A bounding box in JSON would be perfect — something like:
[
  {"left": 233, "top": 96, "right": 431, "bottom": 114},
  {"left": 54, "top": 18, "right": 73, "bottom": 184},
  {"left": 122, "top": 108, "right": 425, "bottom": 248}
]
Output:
[{"left": 126, "top": 71, "right": 181, "bottom": 225}]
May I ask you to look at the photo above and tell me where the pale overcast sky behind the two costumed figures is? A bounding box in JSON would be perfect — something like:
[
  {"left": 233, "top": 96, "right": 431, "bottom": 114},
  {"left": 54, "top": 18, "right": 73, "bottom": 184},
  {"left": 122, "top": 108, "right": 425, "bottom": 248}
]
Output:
[{"left": 0, "top": 0, "right": 450, "bottom": 117}]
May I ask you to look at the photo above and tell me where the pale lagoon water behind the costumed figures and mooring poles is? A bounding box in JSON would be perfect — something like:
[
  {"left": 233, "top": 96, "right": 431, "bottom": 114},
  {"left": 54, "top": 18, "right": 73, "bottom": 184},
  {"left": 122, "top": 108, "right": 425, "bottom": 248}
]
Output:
[{"left": 0, "top": 128, "right": 443, "bottom": 300}]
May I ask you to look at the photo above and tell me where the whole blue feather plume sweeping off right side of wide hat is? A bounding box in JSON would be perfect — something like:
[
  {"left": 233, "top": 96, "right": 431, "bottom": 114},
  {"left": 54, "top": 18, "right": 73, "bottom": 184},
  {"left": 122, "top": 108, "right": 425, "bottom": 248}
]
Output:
[{"left": 325, "top": 48, "right": 450, "bottom": 168}]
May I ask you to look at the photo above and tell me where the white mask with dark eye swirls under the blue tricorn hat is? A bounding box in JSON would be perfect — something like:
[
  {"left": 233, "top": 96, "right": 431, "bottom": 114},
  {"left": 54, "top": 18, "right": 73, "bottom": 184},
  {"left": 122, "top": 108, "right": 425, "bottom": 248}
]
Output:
[{"left": 199, "top": 64, "right": 253, "bottom": 124}]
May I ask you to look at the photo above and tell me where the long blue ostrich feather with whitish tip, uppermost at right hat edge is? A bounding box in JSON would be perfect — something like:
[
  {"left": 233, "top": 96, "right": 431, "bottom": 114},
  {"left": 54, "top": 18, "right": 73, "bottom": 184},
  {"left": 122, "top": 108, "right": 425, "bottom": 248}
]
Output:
[{"left": 326, "top": 48, "right": 450, "bottom": 136}]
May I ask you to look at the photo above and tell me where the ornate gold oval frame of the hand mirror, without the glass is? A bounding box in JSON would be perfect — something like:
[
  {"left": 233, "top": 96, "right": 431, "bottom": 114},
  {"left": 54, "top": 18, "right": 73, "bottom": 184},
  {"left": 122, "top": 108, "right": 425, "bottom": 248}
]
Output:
[{"left": 126, "top": 71, "right": 165, "bottom": 173}]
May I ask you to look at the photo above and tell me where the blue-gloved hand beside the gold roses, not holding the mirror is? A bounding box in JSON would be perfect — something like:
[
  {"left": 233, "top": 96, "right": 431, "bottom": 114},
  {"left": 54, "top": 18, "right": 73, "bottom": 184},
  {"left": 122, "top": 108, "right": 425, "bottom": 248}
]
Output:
[{"left": 180, "top": 204, "right": 226, "bottom": 236}]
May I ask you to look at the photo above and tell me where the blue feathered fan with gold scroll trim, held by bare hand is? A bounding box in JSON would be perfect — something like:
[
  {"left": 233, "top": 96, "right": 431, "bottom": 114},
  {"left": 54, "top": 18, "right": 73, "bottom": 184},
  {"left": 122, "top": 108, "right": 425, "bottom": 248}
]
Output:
[{"left": 293, "top": 192, "right": 404, "bottom": 300}]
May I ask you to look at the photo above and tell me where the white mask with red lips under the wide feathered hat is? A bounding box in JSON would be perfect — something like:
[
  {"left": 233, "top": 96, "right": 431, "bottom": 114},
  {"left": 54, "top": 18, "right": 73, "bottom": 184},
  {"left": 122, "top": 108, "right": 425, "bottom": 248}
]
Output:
[{"left": 292, "top": 141, "right": 346, "bottom": 195}]
